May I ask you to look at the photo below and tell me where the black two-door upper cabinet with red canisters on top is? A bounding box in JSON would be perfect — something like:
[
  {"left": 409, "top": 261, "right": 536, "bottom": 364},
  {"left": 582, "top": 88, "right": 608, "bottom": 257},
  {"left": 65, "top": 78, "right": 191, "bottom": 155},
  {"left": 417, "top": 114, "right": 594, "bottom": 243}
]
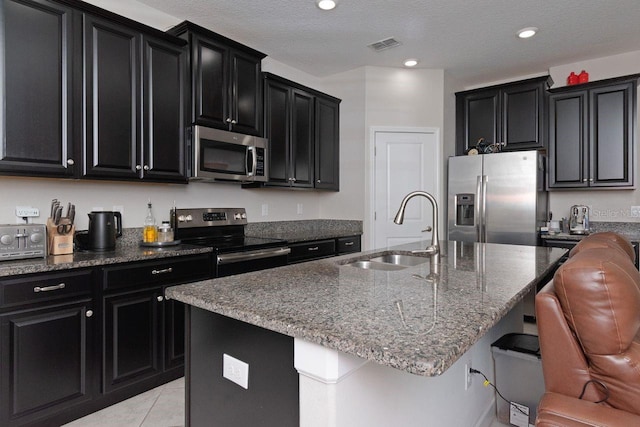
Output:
[{"left": 549, "top": 75, "right": 640, "bottom": 189}]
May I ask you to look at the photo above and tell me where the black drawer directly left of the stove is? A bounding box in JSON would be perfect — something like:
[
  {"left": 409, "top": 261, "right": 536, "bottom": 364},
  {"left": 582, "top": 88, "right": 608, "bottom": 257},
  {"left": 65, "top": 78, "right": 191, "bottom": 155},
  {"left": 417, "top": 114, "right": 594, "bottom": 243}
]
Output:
[{"left": 102, "top": 254, "right": 211, "bottom": 290}]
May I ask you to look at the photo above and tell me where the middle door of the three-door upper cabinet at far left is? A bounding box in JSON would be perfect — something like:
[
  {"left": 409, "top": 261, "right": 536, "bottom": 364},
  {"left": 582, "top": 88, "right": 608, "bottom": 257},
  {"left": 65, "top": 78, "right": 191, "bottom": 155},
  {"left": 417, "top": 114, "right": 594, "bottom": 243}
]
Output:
[{"left": 83, "top": 15, "right": 142, "bottom": 178}]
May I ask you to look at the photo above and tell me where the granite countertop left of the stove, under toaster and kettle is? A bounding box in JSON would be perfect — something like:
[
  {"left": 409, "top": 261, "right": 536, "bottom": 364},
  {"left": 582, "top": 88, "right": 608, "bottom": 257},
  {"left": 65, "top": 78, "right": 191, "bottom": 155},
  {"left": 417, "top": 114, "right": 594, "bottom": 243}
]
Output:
[{"left": 0, "top": 245, "right": 211, "bottom": 277}]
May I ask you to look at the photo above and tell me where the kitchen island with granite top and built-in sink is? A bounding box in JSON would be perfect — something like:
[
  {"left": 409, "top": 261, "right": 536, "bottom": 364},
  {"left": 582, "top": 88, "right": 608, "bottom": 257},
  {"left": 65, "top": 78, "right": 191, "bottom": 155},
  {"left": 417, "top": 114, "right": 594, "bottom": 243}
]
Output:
[{"left": 166, "top": 242, "right": 566, "bottom": 426}]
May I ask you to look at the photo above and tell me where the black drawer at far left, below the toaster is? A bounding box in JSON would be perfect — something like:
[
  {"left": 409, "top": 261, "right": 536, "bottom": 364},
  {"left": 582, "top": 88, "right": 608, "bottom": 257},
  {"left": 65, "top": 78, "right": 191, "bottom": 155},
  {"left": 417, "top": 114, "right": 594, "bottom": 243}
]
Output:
[{"left": 0, "top": 270, "right": 92, "bottom": 308}]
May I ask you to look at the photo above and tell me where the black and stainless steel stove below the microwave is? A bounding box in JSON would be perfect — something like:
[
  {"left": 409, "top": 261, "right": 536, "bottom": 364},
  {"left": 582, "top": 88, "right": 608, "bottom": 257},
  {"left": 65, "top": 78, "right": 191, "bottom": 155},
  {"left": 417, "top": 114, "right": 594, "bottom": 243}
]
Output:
[{"left": 171, "top": 208, "right": 291, "bottom": 277}]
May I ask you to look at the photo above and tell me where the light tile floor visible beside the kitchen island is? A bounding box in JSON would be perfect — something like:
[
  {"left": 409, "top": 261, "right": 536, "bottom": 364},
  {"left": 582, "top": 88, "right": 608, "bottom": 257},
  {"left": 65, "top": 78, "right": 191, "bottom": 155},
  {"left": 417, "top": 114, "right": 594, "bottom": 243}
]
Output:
[{"left": 63, "top": 378, "right": 184, "bottom": 427}]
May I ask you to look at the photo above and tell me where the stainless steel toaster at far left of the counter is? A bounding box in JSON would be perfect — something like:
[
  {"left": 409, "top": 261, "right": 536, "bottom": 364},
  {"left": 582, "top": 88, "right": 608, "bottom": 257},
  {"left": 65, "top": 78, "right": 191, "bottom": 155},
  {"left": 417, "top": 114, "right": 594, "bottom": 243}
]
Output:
[{"left": 0, "top": 224, "right": 47, "bottom": 261}]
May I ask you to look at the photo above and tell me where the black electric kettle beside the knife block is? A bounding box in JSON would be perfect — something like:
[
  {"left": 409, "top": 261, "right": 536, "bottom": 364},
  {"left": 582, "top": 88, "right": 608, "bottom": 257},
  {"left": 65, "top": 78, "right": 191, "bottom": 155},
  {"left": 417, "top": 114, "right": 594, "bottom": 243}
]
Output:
[{"left": 75, "top": 211, "right": 122, "bottom": 252}]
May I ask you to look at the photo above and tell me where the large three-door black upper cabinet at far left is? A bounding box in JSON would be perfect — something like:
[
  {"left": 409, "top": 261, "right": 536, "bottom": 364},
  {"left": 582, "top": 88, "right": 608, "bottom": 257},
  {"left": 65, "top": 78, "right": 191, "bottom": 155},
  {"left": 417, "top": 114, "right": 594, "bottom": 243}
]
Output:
[{"left": 0, "top": 0, "right": 187, "bottom": 183}]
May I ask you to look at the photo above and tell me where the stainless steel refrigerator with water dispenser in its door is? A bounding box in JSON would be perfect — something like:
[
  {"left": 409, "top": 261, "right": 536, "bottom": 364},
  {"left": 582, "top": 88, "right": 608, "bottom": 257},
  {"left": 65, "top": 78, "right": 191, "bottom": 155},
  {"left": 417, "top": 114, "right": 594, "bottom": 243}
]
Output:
[{"left": 448, "top": 151, "right": 549, "bottom": 245}]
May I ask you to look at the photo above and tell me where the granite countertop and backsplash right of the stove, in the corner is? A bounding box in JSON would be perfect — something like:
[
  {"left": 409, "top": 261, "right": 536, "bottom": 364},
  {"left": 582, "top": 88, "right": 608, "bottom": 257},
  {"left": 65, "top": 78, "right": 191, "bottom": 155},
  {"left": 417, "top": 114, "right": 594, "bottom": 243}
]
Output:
[{"left": 245, "top": 219, "right": 362, "bottom": 243}]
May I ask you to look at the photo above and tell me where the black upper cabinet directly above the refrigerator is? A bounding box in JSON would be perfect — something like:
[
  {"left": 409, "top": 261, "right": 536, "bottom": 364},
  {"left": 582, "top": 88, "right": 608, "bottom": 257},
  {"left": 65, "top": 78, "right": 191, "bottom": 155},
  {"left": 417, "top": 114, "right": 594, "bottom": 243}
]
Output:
[{"left": 456, "top": 76, "right": 552, "bottom": 155}]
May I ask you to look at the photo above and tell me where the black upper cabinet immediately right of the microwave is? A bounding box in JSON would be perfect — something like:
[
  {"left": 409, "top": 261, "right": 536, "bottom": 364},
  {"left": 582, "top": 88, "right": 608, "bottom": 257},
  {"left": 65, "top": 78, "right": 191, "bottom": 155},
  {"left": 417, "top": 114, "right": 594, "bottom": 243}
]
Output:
[{"left": 263, "top": 73, "right": 340, "bottom": 191}]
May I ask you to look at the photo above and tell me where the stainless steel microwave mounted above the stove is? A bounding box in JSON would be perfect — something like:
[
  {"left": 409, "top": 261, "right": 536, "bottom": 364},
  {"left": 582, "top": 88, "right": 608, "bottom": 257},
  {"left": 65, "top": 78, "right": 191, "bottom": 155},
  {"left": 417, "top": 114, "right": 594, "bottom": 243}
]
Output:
[{"left": 189, "top": 125, "right": 269, "bottom": 182}]
